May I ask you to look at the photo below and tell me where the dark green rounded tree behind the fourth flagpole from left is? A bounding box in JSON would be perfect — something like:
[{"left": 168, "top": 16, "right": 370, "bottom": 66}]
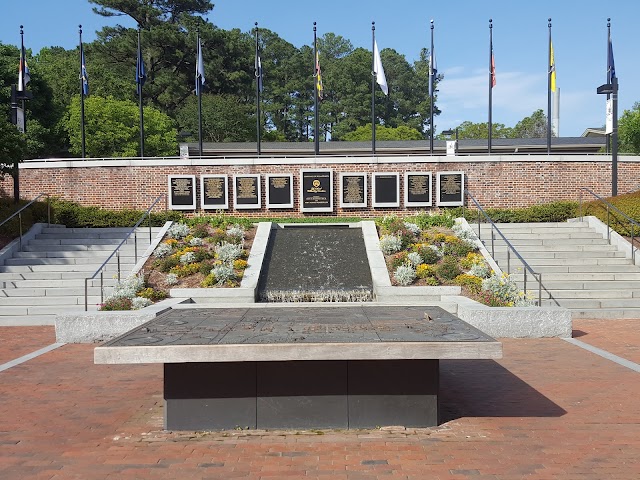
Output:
[{"left": 177, "top": 94, "right": 256, "bottom": 142}]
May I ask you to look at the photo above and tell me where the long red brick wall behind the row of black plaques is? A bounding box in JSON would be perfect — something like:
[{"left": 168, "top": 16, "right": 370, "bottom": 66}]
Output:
[{"left": 0, "top": 155, "right": 640, "bottom": 217}]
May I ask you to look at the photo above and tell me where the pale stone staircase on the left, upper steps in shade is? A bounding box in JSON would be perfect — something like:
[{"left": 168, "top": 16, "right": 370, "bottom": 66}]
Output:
[{"left": 0, "top": 225, "right": 160, "bottom": 325}]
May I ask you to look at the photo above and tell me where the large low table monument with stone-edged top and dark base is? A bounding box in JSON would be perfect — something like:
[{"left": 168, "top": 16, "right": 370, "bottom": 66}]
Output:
[{"left": 94, "top": 304, "right": 502, "bottom": 430}]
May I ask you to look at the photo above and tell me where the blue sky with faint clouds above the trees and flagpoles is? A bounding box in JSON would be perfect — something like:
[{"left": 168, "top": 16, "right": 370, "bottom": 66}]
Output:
[{"left": 0, "top": 0, "right": 640, "bottom": 136}]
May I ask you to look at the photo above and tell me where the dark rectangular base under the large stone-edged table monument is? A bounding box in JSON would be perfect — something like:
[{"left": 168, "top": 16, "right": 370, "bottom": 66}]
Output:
[{"left": 164, "top": 360, "right": 439, "bottom": 430}]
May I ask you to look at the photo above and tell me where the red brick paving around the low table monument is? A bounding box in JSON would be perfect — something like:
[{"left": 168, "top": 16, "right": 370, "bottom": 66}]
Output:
[{"left": 0, "top": 320, "right": 640, "bottom": 480}]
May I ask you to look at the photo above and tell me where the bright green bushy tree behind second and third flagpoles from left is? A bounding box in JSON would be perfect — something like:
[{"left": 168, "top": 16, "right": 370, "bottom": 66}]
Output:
[{"left": 66, "top": 95, "right": 178, "bottom": 158}]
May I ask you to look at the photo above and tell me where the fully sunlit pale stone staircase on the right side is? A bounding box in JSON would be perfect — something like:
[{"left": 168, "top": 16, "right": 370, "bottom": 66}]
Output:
[{"left": 472, "top": 221, "right": 640, "bottom": 318}]
